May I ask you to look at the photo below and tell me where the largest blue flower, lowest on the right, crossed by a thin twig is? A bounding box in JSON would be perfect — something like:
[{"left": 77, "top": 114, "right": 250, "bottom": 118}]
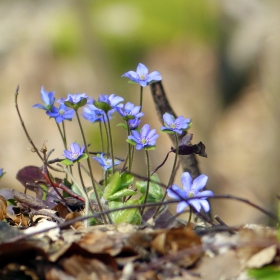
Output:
[{"left": 167, "top": 172, "right": 214, "bottom": 213}]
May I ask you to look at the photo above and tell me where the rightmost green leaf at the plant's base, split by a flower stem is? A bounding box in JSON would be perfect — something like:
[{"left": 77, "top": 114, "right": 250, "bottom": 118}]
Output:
[{"left": 135, "top": 173, "right": 163, "bottom": 203}]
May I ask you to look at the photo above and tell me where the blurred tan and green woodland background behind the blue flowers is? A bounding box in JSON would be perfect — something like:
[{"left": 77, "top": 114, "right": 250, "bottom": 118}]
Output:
[{"left": 0, "top": 0, "right": 280, "bottom": 225}]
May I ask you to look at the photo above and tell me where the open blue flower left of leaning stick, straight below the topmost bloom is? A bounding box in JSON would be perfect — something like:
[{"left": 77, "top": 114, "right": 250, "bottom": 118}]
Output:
[{"left": 128, "top": 124, "right": 158, "bottom": 150}]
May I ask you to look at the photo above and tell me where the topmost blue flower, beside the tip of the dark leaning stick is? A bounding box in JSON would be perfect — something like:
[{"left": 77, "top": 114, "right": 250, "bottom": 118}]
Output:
[{"left": 122, "top": 63, "right": 162, "bottom": 87}]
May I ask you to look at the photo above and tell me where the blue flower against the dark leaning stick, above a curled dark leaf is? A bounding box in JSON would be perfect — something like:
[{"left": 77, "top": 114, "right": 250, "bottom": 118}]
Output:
[{"left": 161, "top": 113, "right": 191, "bottom": 134}]
